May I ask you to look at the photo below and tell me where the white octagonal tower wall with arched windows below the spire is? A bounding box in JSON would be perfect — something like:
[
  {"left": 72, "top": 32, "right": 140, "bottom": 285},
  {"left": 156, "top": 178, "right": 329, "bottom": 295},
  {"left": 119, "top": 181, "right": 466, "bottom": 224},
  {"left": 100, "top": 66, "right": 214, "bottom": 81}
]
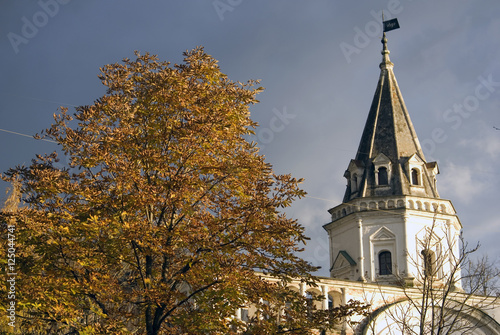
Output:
[{"left": 324, "top": 196, "right": 461, "bottom": 284}]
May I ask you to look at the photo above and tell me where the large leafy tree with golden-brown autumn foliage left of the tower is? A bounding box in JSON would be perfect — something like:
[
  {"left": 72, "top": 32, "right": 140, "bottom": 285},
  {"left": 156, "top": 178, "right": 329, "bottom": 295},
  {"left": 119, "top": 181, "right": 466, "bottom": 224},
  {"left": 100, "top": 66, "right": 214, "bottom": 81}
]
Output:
[{"left": 0, "top": 48, "right": 368, "bottom": 335}]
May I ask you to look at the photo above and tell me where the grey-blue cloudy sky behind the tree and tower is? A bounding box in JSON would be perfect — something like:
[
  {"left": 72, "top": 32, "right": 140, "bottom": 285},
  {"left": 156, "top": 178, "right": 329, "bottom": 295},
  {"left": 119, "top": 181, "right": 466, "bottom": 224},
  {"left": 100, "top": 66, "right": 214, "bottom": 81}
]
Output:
[{"left": 0, "top": 0, "right": 500, "bottom": 274}]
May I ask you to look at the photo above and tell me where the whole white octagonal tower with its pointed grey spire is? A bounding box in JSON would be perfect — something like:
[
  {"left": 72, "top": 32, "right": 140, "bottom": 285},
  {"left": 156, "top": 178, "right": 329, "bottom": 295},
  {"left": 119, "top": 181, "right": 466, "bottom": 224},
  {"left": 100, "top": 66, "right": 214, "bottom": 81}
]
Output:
[{"left": 323, "top": 33, "right": 462, "bottom": 284}]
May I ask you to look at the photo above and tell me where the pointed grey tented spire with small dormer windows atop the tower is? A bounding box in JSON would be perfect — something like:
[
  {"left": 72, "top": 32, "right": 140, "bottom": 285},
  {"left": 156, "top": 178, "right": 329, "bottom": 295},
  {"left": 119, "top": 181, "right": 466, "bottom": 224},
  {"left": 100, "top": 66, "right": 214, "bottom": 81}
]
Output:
[{"left": 344, "top": 32, "right": 439, "bottom": 202}]
